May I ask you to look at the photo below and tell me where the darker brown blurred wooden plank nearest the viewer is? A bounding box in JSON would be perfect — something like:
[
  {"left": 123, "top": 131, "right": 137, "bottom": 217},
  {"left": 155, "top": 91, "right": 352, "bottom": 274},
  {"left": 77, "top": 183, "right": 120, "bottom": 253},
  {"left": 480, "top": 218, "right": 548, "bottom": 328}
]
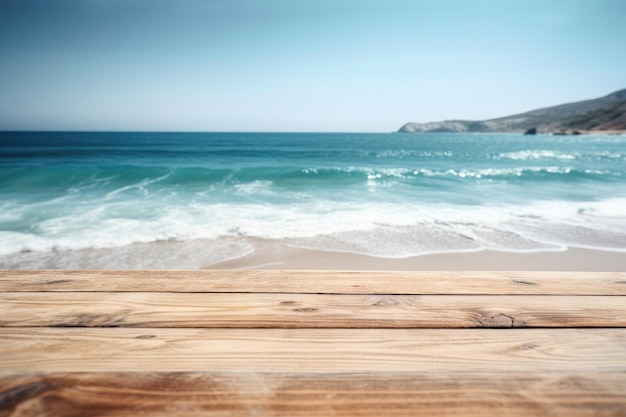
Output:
[{"left": 0, "top": 370, "right": 626, "bottom": 417}]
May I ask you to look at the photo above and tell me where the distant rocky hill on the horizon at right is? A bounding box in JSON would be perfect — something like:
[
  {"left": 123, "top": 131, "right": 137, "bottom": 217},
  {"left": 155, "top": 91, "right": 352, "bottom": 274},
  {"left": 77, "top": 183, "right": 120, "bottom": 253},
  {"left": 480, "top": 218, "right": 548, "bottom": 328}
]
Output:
[{"left": 398, "top": 89, "right": 626, "bottom": 133}]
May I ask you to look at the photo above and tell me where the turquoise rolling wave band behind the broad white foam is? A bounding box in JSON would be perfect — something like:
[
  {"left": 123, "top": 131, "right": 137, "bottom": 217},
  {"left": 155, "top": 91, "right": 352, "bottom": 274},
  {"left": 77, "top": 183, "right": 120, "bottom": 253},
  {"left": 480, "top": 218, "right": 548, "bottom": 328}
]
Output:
[{"left": 0, "top": 165, "right": 624, "bottom": 204}]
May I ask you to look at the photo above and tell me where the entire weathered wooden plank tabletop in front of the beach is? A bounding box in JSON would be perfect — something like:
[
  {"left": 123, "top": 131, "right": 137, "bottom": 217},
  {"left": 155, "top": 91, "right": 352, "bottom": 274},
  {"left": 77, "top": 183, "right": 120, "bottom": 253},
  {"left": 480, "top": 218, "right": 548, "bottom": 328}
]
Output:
[{"left": 0, "top": 271, "right": 626, "bottom": 417}]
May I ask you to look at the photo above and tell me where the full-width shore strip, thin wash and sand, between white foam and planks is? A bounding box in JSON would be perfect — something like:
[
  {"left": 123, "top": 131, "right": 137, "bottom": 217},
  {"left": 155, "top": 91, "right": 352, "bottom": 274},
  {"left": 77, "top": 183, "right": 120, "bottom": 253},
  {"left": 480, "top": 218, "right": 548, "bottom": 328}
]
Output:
[{"left": 0, "top": 238, "right": 626, "bottom": 272}]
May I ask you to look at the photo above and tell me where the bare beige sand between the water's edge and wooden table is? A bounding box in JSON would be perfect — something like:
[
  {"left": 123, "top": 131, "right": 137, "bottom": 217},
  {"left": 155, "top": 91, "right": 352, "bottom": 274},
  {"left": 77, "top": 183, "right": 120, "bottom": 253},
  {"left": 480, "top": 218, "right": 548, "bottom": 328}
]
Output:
[{"left": 205, "top": 241, "right": 626, "bottom": 272}]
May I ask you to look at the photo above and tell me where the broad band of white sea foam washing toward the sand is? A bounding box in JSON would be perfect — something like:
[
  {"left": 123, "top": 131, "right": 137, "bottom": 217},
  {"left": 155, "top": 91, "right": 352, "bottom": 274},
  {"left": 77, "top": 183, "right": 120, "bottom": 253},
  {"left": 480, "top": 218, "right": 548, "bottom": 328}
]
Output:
[{"left": 0, "top": 199, "right": 626, "bottom": 257}]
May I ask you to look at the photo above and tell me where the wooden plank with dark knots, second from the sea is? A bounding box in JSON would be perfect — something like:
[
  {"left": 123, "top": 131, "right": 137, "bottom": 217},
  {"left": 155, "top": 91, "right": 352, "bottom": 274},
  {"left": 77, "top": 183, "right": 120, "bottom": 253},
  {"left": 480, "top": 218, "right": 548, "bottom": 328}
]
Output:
[{"left": 0, "top": 292, "right": 626, "bottom": 328}]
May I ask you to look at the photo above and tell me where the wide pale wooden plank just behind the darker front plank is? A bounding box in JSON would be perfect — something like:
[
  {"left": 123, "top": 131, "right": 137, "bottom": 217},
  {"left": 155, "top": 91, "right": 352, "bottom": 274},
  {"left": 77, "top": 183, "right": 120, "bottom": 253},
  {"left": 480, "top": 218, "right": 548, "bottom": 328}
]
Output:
[{"left": 0, "top": 328, "right": 626, "bottom": 372}]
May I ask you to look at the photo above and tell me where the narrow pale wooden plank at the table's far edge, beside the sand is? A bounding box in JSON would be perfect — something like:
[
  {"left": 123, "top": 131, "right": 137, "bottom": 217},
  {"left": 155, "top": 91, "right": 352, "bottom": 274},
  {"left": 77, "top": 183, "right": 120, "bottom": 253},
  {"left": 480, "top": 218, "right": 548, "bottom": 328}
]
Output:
[{"left": 0, "top": 270, "right": 626, "bottom": 295}]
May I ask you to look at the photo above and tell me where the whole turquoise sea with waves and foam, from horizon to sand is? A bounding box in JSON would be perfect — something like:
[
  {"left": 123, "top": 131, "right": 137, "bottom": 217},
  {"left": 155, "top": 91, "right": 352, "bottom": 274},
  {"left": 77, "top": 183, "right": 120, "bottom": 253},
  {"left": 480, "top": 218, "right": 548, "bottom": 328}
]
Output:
[{"left": 0, "top": 132, "right": 626, "bottom": 269}]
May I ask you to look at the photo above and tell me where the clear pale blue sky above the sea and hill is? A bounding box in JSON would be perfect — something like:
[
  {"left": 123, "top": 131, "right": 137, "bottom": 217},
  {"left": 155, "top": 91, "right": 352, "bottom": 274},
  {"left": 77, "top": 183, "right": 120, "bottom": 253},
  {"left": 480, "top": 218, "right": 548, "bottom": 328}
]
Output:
[{"left": 0, "top": 0, "right": 626, "bottom": 132}]
